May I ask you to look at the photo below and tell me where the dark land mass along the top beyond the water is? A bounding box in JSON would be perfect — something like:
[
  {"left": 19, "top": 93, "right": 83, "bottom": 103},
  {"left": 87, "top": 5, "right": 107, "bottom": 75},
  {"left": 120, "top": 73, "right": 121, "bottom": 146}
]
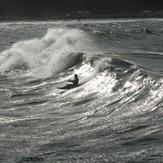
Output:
[{"left": 0, "top": 0, "right": 163, "bottom": 21}]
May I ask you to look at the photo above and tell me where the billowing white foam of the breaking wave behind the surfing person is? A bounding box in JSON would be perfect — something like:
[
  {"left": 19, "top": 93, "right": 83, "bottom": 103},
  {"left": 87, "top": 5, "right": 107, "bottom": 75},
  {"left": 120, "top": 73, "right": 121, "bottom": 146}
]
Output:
[{"left": 0, "top": 28, "right": 88, "bottom": 77}]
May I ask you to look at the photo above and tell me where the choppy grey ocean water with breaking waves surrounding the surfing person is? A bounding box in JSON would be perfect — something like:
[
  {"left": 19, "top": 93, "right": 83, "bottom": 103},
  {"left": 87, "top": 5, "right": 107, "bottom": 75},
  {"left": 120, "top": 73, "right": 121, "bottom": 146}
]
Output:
[{"left": 0, "top": 19, "right": 163, "bottom": 163}]
